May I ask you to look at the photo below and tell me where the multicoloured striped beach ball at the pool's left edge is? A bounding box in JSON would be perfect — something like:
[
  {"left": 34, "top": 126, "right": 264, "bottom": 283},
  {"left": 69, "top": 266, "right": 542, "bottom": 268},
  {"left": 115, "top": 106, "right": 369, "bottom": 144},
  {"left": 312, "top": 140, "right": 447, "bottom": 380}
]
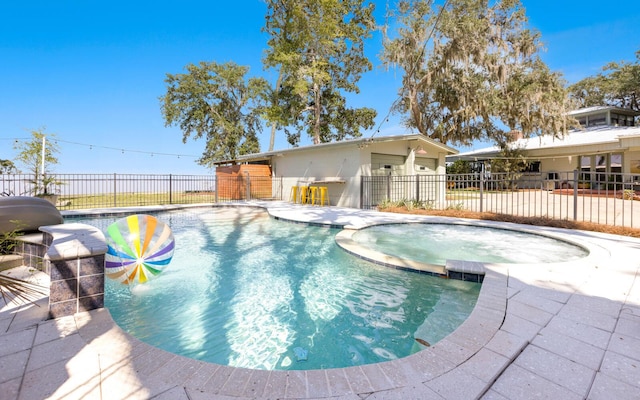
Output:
[{"left": 105, "top": 215, "right": 175, "bottom": 285}]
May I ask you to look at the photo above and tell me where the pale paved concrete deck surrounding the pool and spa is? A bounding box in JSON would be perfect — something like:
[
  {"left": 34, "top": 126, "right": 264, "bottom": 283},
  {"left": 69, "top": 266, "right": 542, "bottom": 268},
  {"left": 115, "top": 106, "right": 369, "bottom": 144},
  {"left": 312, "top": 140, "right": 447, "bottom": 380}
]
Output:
[{"left": 0, "top": 202, "right": 640, "bottom": 400}]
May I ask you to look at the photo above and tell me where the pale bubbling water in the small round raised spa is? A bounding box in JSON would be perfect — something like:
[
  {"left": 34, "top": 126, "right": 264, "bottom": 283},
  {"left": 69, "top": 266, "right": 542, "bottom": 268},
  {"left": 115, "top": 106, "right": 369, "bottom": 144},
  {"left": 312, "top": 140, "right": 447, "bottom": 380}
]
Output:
[{"left": 352, "top": 223, "right": 588, "bottom": 265}]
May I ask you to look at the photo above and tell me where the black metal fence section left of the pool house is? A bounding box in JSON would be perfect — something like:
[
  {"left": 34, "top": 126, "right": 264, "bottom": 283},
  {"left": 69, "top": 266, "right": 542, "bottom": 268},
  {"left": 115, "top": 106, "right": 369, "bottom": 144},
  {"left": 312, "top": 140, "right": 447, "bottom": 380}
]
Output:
[{"left": 0, "top": 174, "right": 282, "bottom": 210}]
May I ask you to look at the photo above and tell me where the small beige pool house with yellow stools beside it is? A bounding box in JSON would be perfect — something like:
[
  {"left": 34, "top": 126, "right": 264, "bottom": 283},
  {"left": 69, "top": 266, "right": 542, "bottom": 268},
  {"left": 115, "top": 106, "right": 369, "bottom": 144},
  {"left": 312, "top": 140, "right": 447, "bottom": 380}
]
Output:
[{"left": 218, "top": 134, "right": 457, "bottom": 208}]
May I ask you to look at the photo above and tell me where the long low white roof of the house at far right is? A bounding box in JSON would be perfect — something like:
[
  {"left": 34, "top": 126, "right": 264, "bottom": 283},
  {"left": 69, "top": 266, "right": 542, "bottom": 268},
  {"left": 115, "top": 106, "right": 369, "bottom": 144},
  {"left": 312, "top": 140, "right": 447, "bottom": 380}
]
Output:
[{"left": 447, "top": 126, "right": 640, "bottom": 161}]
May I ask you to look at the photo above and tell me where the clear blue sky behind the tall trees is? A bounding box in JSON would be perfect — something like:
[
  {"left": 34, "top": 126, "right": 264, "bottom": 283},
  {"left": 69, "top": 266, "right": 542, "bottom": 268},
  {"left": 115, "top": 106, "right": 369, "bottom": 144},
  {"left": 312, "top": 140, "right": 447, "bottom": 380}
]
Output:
[{"left": 0, "top": 0, "right": 640, "bottom": 174}]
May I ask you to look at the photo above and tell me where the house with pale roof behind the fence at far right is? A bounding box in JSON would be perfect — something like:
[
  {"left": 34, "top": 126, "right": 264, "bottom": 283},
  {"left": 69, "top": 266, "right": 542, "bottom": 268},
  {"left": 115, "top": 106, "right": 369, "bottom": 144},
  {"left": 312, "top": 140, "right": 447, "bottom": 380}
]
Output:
[{"left": 447, "top": 106, "right": 640, "bottom": 188}]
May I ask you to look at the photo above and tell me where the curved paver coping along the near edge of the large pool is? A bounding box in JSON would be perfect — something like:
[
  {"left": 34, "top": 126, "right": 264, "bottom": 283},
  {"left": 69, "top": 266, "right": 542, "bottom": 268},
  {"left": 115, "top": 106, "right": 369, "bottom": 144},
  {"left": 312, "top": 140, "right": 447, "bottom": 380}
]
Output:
[{"left": 62, "top": 267, "right": 508, "bottom": 399}]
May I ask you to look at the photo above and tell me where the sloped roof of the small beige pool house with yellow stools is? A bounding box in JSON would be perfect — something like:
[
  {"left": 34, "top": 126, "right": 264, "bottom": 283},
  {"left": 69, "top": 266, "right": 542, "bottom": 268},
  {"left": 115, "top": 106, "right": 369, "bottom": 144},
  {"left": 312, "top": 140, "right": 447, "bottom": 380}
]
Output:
[{"left": 215, "top": 133, "right": 458, "bottom": 165}]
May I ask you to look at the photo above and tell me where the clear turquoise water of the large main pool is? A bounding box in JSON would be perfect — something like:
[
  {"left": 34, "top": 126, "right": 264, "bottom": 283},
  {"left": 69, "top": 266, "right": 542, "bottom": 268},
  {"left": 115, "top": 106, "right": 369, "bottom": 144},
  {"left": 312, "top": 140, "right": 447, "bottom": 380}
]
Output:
[{"left": 74, "top": 208, "right": 480, "bottom": 370}]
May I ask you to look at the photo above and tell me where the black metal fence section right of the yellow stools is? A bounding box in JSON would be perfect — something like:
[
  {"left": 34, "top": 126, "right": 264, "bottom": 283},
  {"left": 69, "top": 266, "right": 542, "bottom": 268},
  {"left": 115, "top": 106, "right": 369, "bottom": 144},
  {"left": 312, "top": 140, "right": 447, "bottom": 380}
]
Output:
[{"left": 361, "top": 171, "right": 640, "bottom": 228}]
